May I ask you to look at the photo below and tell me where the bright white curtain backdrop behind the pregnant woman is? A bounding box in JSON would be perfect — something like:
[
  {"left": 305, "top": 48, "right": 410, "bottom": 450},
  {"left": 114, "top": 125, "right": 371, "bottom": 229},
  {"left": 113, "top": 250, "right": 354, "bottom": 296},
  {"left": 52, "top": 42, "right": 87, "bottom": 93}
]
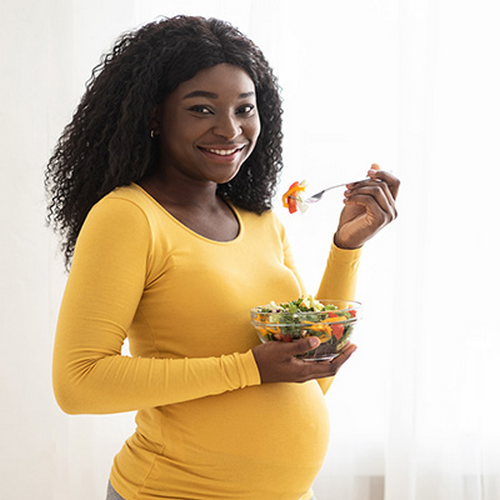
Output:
[{"left": 0, "top": 0, "right": 500, "bottom": 500}]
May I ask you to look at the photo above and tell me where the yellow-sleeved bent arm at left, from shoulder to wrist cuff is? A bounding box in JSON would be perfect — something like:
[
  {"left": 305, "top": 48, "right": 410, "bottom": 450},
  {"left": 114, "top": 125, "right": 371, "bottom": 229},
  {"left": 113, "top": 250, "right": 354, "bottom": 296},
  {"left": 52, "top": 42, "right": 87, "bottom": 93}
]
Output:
[{"left": 53, "top": 199, "right": 260, "bottom": 414}]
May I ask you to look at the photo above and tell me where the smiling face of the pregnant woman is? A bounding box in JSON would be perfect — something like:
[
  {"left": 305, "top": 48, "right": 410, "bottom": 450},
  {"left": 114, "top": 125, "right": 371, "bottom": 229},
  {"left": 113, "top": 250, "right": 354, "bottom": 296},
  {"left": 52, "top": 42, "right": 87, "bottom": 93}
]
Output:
[{"left": 157, "top": 63, "right": 260, "bottom": 184}]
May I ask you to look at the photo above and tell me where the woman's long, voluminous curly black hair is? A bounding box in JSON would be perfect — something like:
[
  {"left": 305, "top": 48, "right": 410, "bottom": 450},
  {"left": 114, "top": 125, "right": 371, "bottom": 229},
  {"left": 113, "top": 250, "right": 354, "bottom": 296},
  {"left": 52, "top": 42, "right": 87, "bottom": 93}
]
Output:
[{"left": 45, "top": 16, "right": 283, "bottom": 267}]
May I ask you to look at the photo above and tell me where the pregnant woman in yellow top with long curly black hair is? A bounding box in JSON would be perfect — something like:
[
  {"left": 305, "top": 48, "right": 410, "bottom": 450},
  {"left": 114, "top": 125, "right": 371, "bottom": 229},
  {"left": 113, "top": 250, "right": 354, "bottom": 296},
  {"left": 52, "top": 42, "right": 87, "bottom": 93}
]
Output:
[{"left": 46, "top": 16, "right": 399, "bottom": 500}]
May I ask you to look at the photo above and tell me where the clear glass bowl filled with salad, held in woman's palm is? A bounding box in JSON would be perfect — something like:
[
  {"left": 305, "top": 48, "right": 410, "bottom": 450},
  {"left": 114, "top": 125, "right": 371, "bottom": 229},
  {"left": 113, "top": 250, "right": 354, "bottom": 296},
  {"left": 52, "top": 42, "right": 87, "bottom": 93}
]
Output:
[{"left": 250, "top": 299, "right": 361, "bottom": 361}]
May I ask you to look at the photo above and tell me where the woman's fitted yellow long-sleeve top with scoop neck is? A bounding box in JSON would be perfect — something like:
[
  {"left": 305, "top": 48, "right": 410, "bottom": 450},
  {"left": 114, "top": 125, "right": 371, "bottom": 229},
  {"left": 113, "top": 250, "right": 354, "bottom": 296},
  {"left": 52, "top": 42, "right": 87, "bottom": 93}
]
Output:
[{"left": 53, "top": 184, "right": 360, "bottom": 500}]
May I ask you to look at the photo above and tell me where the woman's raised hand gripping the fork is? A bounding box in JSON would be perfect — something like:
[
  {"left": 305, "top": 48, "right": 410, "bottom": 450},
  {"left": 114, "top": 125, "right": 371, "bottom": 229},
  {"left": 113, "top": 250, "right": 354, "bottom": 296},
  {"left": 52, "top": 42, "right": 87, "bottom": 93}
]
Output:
[{"left": 334, "top": 165, "right": 400, "bottom": 249}]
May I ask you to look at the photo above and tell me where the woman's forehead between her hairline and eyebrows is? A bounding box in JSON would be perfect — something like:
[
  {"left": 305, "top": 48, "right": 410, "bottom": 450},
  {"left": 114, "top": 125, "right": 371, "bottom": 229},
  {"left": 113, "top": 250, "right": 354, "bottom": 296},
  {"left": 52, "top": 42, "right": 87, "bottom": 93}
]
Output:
[{"left": 174, "top": 63, "right": 255, "bottom": 99}]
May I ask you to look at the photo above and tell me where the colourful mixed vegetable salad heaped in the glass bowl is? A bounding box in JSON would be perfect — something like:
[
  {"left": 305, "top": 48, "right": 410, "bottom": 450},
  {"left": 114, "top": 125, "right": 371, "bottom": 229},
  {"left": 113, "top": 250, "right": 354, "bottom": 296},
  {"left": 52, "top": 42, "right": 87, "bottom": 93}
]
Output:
[{"left": 251, "top": 296, "right": 357, "bottom": 350}]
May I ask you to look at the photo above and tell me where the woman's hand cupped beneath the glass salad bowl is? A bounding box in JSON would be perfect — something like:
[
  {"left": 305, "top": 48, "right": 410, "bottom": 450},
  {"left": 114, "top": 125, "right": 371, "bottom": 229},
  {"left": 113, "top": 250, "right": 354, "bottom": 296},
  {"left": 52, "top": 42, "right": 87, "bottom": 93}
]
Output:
[{"left": 252, "top": 337, "right": 357, "bottom": 384}]
